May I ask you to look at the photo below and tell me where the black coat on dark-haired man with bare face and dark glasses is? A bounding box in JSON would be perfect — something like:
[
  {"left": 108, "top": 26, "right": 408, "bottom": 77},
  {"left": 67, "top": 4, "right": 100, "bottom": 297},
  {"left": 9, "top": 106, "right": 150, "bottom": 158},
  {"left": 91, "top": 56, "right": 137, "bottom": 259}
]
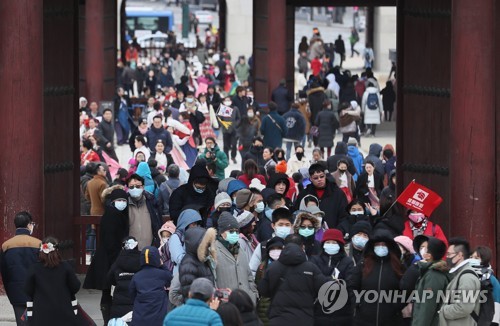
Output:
[{"left": 295, "top": 179, "right": 348, "bottom": 228}]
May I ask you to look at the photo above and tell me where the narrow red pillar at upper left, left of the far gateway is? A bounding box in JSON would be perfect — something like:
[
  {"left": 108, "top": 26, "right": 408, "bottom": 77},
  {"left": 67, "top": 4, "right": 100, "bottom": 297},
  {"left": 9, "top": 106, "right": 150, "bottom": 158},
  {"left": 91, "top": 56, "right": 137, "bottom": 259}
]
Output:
[{"left": 85, "top": 0, "right": 104, "bottom": 102}]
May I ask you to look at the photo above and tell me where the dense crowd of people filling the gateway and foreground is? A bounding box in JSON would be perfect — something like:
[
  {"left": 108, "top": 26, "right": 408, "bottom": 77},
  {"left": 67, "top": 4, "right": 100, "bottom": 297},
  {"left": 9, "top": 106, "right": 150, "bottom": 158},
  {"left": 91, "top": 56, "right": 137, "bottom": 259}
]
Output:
[{"left": 1, "top": 27, "right": 500, "bottom": 325}]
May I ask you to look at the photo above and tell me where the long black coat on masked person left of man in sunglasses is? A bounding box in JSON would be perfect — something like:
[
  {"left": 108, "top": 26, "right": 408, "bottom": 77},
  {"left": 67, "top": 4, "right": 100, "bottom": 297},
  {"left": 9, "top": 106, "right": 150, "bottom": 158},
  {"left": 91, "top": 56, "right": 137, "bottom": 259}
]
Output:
[{"left": 83, "top": 205, "right": 128, "bottom": 290}]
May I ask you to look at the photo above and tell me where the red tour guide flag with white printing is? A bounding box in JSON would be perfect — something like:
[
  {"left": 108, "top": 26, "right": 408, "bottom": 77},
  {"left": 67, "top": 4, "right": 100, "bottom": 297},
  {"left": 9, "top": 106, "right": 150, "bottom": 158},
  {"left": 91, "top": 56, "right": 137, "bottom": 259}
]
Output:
[{"left": 397, "top": 181, "right": 443, "bottom": 216}]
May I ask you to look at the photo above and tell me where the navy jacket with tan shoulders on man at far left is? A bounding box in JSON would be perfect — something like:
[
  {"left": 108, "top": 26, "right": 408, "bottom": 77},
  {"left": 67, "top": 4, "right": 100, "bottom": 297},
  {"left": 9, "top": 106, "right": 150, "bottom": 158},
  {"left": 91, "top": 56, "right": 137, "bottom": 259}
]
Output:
[{"left": 0, "top": 228, "right": 42, "bottom": 305}]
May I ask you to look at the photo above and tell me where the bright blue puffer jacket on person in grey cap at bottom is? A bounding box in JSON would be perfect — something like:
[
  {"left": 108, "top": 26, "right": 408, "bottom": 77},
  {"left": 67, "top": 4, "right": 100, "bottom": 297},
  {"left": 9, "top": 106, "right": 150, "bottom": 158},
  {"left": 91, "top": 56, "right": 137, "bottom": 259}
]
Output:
[{"left": 163, "top": 299, "right": 223, "bottom": 326}]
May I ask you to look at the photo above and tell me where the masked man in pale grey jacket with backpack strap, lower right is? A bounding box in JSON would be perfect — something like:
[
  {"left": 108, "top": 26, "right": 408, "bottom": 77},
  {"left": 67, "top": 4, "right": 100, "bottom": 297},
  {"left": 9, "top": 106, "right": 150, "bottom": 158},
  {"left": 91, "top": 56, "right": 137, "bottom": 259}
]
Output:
[{"left": 438, "top": 238, "right": 481, "bottom": 325}]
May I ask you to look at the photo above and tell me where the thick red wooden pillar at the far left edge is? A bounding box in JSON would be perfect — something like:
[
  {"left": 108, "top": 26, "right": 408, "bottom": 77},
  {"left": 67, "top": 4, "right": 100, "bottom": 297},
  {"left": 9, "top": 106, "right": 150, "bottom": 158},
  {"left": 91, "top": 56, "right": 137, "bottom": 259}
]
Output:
[{"left": 0, "top": 0, "right": 44, "bottom": 242}]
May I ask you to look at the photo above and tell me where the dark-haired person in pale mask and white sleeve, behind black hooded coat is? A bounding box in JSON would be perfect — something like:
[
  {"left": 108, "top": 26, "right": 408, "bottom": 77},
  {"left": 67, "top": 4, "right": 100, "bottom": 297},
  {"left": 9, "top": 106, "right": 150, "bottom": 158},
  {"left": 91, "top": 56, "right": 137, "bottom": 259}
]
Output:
[{"left": 250, "top": 208, "right": 293, "bottom": 275}]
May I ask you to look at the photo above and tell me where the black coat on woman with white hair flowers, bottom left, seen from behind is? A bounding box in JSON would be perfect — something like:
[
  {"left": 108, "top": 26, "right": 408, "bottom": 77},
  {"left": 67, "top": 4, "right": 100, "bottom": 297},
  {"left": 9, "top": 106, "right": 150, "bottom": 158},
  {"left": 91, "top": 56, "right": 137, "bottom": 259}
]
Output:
[{"left": 24, "top": 262, "right": 80, "bottom": 326}]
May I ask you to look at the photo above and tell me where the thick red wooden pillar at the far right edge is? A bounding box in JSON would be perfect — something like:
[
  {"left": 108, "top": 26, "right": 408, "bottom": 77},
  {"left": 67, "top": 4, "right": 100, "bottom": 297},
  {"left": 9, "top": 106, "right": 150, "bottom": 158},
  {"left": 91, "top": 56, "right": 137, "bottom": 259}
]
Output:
[{"left": 450, "top": 0, "right": 496, "bottom": 251}]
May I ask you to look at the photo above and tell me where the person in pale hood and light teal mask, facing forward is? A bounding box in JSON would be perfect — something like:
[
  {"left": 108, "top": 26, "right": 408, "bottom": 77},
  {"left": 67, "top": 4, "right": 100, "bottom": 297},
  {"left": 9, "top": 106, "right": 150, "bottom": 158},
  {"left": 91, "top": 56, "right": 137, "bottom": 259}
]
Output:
[{"left": 293, "top": 212, "right": 321, "bottom": 259}]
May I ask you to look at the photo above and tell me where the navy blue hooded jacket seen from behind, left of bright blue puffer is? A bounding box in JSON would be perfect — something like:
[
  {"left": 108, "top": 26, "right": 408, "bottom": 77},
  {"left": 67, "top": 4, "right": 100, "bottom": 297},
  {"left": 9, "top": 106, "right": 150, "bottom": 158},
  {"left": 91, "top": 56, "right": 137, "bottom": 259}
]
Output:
[{"left": 129, "top": 247, "right": 172, "bottom": 326}]
